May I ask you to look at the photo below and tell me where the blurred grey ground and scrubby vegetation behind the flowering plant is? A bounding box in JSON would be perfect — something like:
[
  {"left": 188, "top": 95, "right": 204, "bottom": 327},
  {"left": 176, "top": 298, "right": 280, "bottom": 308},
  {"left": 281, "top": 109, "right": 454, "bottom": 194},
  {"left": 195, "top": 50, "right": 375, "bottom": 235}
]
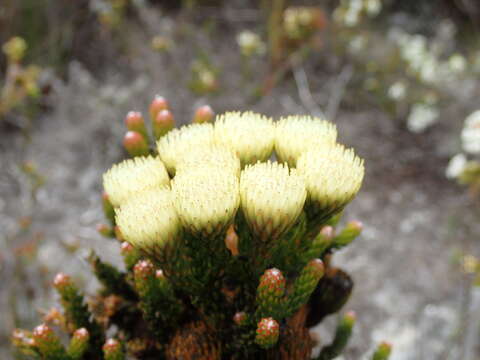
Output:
[{"left": 0, "top": 0, "right": 480, "bottom": 360}]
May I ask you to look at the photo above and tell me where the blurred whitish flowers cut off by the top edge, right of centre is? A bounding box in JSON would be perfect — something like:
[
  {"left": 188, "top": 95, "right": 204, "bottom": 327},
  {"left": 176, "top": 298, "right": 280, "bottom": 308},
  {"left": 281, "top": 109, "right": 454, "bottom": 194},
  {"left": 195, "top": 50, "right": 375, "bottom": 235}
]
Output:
[{"left": 333, "top": 0, "right": 382, "bottom": 27}]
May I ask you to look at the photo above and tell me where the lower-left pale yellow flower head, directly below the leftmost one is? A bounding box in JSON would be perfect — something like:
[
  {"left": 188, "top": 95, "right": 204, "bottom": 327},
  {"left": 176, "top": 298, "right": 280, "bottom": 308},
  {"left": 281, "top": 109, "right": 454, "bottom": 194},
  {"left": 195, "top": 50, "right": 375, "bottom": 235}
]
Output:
[{"left": 115, "top": 188, "right": 180, "bottom": 255}]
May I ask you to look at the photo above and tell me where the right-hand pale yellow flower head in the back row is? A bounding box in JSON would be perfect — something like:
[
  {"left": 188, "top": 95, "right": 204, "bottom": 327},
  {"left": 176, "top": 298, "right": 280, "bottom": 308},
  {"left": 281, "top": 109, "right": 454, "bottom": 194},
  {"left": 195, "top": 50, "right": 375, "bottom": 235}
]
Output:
[{"left": 275, "top": 115, "right": 337, "bottom": 167}]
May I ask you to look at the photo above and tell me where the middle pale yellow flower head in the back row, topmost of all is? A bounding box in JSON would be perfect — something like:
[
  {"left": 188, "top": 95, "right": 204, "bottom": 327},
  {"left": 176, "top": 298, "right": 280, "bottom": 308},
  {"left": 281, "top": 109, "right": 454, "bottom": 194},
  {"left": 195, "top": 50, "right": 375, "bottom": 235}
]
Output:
[{"left": 215, "top": 112, "right": 275, "bottom": 165}]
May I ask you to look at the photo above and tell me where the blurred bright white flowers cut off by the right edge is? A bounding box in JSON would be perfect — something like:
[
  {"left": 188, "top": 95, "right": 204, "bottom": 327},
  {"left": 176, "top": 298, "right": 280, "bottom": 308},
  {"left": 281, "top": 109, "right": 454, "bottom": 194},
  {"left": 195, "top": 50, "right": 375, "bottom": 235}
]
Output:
[{"left": 445, "top": 110, "right": 480, "bottom": 180}]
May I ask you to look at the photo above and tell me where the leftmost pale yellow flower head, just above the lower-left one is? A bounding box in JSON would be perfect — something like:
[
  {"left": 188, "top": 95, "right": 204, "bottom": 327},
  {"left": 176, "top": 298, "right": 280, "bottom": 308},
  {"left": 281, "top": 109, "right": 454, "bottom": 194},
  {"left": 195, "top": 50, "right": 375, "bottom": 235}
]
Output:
[{"left": 103, "top": 156, "right": 170, "bottom": 206}]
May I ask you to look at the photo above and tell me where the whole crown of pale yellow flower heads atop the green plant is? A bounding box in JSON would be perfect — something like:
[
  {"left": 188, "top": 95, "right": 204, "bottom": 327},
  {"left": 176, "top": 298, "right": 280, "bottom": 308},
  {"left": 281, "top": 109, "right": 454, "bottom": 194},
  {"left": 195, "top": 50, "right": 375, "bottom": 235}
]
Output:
[{"left": 104, "top": 112, "right": 364, "bottom": 253}]
